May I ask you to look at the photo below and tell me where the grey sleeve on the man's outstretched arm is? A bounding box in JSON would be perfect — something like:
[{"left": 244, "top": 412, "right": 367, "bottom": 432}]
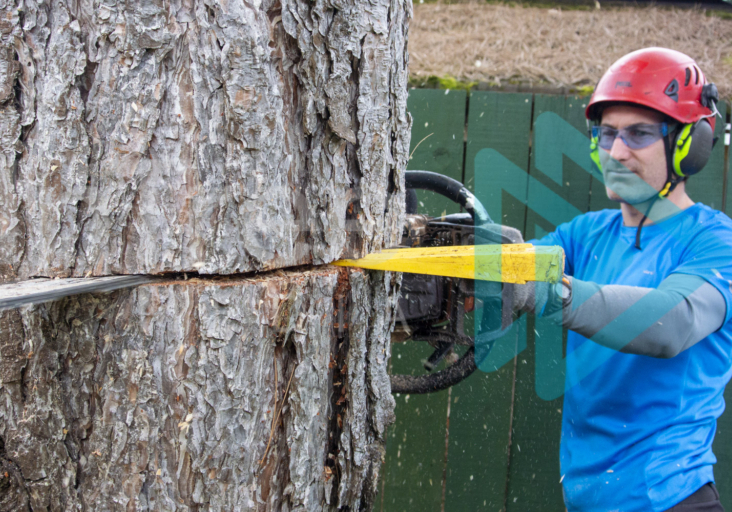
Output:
[{"left": 562, "top": 274, "right": 726, "bottom": 358}]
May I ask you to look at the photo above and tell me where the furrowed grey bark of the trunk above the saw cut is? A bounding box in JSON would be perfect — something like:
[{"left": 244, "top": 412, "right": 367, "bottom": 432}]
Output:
[{"left": 0, "top": 0, "right": 411, "bottom": 280}]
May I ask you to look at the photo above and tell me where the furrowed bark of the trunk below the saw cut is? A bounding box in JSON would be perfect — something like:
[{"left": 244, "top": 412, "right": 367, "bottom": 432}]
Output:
[{"left": 0, "top": 268, "right": 394, "bottom": 512}]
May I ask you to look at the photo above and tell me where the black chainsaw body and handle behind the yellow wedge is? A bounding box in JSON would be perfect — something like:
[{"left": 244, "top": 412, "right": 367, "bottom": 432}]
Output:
[{"left": 391, "top": 171, "right": 522, "bottom": 394}]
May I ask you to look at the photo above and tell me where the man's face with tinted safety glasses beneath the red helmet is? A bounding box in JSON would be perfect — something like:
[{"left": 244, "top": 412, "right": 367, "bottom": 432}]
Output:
[{"left": 600, "top": 105, "right": 666, "bottom": 204}]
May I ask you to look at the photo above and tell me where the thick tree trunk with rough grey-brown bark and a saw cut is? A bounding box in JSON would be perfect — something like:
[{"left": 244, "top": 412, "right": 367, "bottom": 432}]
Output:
[{"left": 0, "top": 0, "right": 411, "bottom": 512}]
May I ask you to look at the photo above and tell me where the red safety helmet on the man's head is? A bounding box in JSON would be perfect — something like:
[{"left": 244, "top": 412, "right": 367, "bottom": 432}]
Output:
[{"left": 585, "top": 48, "right": 716, "bottom": 130}]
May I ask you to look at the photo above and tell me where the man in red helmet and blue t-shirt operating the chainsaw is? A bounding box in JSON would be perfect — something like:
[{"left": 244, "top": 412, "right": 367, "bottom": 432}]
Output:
[{"left": 519, "top": 48, "right": 732, "bottom": 512}]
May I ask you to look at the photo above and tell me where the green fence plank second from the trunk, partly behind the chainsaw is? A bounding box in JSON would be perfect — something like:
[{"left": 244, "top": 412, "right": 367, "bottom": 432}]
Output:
[{"left": 445, "top": 92, "right": 531, "bottom": 511}]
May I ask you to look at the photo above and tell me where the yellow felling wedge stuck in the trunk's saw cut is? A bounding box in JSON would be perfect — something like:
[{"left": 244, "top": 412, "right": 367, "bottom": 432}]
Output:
[{"left": 333, "top": 244, "right": 564, "bottom": 284}]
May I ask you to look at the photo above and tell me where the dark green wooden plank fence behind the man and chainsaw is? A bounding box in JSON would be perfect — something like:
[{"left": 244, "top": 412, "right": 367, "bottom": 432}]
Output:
[{"left": 380, "top": 89, "right": 732, "bottom": 512}]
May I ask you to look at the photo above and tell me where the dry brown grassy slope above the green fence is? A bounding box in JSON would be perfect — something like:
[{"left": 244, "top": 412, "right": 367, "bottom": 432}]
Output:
[{"left": 409, "top": 4, "right": 732, "bottom": 99}]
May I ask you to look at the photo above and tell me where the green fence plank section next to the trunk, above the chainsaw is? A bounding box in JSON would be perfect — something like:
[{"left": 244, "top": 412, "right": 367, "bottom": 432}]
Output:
[{"left": 407, "top": 89, "right": 467, "bottom": 217}]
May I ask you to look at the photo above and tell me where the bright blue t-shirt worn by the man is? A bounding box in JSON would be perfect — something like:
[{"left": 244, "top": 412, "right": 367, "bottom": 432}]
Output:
[{"left": 535, "top": 203, "right": 732, "bottom": 512}]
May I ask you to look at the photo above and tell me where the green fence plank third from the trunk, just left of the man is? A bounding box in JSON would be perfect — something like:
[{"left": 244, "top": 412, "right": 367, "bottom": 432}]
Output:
[{"left": 507, "top": 95, "right": 591, "bottom": 512}]
